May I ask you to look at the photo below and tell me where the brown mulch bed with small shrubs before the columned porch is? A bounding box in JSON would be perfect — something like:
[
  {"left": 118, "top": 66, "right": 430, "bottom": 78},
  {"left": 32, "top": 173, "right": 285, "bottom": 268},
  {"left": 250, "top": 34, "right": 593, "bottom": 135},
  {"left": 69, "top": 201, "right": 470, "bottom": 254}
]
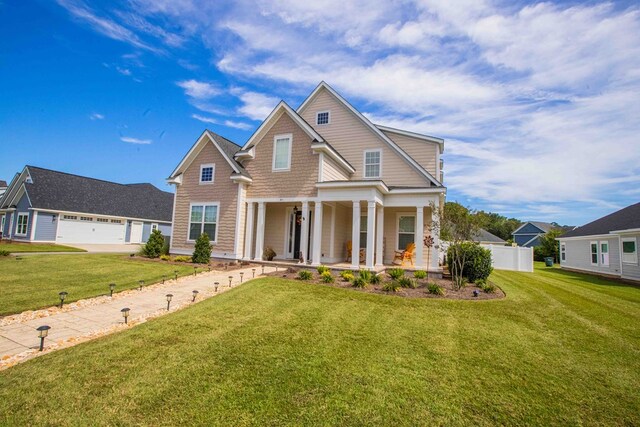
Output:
[{"left": 267, "top": 267, "right": 505, "bottom": 300}]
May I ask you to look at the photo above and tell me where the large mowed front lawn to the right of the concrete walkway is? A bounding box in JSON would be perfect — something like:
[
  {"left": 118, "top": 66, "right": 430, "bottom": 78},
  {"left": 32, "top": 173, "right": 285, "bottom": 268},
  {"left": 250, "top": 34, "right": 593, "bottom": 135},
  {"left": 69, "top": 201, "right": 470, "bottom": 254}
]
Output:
[{"left": 0, "top": 269, "right": 640, "bottom": 426}]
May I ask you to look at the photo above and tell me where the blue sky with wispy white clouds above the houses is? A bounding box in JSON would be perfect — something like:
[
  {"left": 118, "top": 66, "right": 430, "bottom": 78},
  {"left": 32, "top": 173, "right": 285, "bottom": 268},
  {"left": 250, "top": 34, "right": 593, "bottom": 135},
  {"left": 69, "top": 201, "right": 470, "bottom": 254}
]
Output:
[{"left": 0, "top": 0, "right": 640, "bottom": 224}]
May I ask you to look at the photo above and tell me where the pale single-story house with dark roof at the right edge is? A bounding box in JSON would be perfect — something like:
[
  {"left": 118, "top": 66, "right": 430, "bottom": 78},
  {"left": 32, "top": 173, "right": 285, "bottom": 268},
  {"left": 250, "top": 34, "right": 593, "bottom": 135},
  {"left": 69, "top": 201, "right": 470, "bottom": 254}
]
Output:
[{"left": 558, "top": 203, "right": 640, "bottom": 281}]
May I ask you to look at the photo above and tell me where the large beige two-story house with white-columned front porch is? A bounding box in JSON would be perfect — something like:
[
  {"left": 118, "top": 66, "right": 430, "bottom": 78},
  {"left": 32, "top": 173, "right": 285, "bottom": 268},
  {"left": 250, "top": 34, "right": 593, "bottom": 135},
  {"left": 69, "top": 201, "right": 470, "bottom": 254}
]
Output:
[{"left": 168, "top": 82, "right": 446, "bottom": 271}]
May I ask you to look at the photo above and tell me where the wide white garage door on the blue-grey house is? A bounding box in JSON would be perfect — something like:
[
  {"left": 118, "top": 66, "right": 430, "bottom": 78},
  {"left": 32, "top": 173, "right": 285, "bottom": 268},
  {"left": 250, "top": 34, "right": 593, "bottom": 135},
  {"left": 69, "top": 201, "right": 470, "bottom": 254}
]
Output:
[{"left": 56, "top": 215, "right": 125, "bottom": 244}]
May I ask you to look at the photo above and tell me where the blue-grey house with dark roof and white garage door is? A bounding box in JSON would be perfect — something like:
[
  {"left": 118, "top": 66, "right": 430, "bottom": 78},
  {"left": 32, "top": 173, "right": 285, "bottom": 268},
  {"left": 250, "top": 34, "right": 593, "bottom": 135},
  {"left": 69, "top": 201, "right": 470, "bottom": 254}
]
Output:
[{"left": 0, "top": 166, "right": 173, "bottom": 244}]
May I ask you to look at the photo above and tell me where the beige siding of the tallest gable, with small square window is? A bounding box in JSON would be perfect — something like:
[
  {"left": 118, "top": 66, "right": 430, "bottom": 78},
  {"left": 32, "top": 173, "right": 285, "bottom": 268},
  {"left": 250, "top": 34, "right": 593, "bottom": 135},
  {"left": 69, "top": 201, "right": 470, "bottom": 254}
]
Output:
[{"left": 301, "top": 90, "right": 430, "bottom": 187}]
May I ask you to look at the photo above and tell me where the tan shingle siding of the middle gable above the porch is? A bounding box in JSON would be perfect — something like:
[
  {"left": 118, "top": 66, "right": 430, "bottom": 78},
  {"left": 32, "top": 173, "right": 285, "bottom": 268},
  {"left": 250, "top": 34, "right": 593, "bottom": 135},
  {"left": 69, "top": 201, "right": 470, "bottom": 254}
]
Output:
[{"left": 245, "top": 114, "right": 319, "bottom": 198}]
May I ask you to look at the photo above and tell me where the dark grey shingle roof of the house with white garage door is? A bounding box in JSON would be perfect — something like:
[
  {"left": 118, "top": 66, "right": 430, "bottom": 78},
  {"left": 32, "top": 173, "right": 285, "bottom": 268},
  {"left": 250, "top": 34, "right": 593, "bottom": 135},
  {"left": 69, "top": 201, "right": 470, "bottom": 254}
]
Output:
[{"left": 25, "top": 166, "right": 173, "bottom": 222}]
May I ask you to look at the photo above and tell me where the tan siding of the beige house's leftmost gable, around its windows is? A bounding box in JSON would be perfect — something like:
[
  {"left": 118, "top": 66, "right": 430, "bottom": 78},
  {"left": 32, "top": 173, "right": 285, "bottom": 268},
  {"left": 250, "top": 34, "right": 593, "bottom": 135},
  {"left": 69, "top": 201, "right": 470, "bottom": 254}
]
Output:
[{"left": 171, "top": 142, "right": 239, "bottom": 256}]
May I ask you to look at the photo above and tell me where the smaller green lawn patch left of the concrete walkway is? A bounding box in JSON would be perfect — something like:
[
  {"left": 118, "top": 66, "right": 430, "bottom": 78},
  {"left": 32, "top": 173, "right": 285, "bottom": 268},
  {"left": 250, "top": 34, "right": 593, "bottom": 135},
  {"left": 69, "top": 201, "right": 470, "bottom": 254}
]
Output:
[{"left": 0, "top": 254, "right": 199, "bottom": 315}]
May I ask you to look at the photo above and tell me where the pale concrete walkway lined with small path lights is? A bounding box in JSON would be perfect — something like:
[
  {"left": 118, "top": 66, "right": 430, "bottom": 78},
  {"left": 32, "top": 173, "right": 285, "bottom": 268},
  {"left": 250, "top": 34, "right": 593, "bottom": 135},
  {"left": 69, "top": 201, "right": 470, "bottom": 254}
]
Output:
[{"left": 0, "top": 266, "right": 275, "bottom": 368}]
